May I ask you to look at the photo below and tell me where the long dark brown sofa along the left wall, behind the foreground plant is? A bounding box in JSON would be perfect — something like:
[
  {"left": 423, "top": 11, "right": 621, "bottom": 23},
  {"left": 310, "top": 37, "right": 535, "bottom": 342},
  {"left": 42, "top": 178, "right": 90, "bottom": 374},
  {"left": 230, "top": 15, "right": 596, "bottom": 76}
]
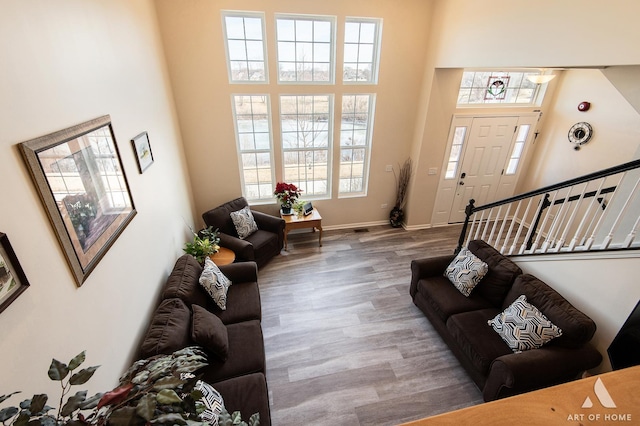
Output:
[{"left": 138, "top": 254, "right": 271, "bottom": 425}]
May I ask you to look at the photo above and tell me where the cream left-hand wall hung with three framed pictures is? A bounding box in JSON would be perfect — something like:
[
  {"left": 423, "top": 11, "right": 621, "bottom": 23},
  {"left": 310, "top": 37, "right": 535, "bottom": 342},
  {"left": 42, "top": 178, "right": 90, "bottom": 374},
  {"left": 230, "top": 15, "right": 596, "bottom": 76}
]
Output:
[{"left": 0, "top": 0, "right": 193, "bottom": 405}]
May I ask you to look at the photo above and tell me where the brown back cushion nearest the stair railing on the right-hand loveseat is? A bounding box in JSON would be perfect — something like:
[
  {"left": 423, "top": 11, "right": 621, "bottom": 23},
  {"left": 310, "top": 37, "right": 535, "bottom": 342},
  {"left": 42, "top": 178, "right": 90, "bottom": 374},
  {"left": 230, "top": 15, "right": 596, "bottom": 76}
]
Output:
[{"left": 468, "top": 240, "right": 522, "bottom": 308}]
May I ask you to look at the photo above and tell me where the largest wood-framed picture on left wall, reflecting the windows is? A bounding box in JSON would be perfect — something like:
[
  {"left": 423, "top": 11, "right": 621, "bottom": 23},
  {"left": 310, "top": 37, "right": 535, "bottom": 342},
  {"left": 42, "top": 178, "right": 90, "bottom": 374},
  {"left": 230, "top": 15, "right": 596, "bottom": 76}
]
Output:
[{"left": 19, "top": 115, "right": 136, "bottom": 286}]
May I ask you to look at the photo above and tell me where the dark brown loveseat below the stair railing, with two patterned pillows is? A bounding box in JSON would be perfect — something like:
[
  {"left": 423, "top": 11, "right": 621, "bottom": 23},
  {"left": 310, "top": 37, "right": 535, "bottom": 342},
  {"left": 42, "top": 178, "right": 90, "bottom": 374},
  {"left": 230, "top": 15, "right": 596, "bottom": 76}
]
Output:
[{"left": 409, "top": 240, "right": 602, "bottom": 401}]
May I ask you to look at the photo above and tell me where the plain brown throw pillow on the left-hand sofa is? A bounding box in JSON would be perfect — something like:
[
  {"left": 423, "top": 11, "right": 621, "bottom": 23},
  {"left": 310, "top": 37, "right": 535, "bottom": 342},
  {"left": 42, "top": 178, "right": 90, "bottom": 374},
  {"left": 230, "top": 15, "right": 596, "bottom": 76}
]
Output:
[{"left": 191, "top": 305, "right": 229, "bottom": 361}]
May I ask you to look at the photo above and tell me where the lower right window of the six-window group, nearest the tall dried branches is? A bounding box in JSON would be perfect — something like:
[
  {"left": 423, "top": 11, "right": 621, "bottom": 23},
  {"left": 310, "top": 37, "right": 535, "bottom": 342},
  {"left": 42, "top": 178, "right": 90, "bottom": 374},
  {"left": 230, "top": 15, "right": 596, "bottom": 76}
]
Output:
[{"left": 338, "top": 95, "right": 375, "bottom": 195}]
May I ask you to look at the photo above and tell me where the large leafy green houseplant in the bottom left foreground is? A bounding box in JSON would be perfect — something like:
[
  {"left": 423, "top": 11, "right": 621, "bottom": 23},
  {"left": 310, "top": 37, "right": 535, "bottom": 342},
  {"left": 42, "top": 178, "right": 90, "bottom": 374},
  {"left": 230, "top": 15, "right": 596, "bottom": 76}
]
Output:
[{"left": 0, "top": 347, "right": 260, "bottom": 426}]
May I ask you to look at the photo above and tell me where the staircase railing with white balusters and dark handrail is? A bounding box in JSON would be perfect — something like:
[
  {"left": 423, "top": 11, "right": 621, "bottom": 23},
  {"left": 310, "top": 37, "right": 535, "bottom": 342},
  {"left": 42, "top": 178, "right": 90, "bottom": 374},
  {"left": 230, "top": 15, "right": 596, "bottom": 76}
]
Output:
[{"left": 456, "top": 160, "right": 640, "bottom": 256}]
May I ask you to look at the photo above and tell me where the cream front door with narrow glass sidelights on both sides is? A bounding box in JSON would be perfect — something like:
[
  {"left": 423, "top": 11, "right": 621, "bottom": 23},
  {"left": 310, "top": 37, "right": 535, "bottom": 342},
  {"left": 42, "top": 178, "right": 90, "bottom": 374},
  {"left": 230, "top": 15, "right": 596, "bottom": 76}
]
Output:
[{"left": 432, "top": 114, "right": 538, "bottom": 225}]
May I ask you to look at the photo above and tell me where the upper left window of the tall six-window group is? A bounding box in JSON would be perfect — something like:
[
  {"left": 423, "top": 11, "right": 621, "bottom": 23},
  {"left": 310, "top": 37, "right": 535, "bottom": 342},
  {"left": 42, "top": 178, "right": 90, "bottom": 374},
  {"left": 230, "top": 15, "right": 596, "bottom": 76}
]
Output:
[{"left": 222, "top": 12, "right": 268, "bottom": 83}]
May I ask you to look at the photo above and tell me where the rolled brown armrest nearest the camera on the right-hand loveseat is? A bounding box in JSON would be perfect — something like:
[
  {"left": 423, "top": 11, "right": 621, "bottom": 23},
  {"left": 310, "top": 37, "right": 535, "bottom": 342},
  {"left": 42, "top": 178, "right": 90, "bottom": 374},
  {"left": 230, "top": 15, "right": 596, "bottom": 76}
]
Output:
[{"left": 482, "top": 343, "right": 602, "bottom": 401}]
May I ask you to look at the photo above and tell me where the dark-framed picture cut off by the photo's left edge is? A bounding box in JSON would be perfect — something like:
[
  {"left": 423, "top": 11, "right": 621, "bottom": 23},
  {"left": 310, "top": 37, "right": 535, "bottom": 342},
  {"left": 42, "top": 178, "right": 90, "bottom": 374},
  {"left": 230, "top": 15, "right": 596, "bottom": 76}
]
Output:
[{"left": 0, "top": 232, "right": 29, "bottom": 312}]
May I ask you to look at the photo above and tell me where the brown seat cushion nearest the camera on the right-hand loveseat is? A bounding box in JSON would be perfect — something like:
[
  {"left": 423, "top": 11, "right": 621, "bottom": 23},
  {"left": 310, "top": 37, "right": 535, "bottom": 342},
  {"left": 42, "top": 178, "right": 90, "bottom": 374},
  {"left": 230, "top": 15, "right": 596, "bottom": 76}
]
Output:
[{"left": 447, "top": 308, "right": 513, "bottom": 375}]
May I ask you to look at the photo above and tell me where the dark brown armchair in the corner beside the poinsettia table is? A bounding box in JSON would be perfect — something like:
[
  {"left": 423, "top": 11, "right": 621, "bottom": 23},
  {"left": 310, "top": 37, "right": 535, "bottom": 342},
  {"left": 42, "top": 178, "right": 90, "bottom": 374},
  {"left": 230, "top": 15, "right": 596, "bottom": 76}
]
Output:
[{"left": 202, "top": 197, "right": 284, "bottom": 267}]
